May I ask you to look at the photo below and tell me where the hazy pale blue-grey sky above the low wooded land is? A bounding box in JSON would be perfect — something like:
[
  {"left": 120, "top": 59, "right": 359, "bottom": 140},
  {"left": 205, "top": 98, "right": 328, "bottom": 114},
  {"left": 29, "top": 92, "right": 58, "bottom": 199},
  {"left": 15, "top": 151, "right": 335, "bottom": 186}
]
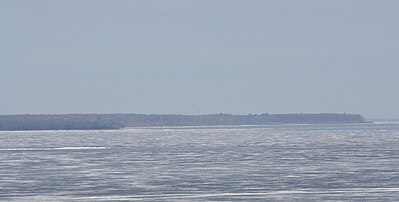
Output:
[{"left": 0, "top": 0, "right": 399, "bottom": 118}]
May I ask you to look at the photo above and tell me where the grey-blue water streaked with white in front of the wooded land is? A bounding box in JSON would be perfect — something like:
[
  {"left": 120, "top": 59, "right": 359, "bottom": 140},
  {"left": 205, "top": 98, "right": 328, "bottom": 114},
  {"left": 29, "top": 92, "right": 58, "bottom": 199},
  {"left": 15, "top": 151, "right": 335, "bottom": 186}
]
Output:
[{"left": 0, "top": 124, "right": 399, "bottom": 201}]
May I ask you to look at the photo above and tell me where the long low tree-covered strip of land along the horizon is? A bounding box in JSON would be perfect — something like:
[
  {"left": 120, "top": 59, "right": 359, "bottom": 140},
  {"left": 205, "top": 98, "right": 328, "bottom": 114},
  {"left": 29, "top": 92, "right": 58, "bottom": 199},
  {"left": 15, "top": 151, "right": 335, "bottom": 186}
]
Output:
[{"left": 0, "top": 113, "right": 366, "bottom": 130}]
